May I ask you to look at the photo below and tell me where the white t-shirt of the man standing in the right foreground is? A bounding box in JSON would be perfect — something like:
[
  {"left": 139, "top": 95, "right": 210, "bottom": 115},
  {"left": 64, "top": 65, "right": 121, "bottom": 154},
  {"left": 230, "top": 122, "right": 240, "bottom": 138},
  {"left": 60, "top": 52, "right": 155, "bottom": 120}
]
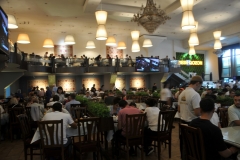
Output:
[{"left": 178, "top": 87, "right": 201, "bottom": 122}]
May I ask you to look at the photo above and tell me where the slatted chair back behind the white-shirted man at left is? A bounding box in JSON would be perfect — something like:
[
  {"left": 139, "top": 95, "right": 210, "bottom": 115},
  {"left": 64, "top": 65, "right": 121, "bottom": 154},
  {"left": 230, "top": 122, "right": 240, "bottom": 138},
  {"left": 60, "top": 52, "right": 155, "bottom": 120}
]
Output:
[{"left": 38, "top": 119, "right": 63, "bottom": 149}]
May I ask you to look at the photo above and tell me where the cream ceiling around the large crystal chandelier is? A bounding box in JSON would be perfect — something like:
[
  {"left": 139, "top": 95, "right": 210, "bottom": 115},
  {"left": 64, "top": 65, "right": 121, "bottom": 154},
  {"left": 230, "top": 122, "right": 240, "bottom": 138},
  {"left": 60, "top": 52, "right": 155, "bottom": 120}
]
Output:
[{"left": 0, "top": 0, "right": 240, "bottom": 49}]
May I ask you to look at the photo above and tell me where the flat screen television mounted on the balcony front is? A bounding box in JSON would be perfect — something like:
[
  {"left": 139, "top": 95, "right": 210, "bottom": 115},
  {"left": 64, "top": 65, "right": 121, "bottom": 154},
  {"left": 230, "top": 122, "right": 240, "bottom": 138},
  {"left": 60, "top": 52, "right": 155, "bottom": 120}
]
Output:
[{"left": 135, "top": 57, "right": 159, "bottom": 72}]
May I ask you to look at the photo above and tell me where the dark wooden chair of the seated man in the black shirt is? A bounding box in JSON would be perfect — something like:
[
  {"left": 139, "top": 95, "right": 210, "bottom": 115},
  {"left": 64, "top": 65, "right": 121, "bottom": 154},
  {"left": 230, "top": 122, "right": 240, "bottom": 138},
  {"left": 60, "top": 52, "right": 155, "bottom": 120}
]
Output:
[{"left": 180, "top": 124, "right": 205, "bottom": 160}]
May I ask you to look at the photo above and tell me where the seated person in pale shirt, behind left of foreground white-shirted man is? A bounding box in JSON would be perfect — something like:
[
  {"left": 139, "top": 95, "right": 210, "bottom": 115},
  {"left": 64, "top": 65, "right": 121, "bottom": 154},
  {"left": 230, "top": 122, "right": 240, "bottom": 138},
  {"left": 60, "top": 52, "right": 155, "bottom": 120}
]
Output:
[{"left": 30, "top": 96, "right": 45, "bottom": 121}]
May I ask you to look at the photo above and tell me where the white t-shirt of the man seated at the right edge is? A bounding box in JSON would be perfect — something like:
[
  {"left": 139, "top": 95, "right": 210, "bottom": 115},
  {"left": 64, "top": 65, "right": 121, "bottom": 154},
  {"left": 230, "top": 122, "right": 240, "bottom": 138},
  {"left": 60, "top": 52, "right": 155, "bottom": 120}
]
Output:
[{"left": 228, "top": 104, "right": 240, "bottom": 127}]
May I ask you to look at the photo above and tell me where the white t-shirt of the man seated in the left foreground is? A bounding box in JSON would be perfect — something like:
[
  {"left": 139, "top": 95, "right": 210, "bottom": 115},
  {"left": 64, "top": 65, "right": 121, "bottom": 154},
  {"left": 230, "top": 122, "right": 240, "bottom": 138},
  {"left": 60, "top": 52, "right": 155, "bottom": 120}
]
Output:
[{"left": 42, "top": 111, "right": 73, "bottom": 144}]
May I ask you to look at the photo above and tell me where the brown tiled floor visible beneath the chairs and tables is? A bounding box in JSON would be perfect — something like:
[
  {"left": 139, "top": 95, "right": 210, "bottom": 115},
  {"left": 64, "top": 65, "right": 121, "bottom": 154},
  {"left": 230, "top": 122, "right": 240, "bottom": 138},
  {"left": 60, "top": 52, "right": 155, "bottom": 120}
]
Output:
[{"left": 0, "top": 123, "right": 180, "bottom": 160}]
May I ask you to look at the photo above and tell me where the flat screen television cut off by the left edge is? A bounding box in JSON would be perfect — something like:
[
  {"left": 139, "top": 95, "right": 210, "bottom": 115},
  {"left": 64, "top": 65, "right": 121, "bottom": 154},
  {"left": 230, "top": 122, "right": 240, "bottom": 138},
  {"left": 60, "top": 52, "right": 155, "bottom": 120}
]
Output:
[{"left": 0, "top": 6, "right": 9, "bottom": 54}]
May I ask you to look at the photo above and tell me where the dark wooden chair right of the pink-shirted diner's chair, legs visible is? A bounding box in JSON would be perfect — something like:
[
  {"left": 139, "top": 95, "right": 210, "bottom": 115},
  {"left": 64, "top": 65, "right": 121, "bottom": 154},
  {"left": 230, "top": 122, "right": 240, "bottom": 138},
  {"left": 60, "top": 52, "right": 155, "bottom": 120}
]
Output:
[{"left": 151, "top": 110, "right": 177, "bottom": 160}]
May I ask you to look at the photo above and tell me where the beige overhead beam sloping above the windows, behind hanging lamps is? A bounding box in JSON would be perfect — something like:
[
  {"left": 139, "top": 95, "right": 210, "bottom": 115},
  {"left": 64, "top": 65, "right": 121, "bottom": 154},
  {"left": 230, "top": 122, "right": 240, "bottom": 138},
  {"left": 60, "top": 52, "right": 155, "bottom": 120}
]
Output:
[{"left": 183, "top": 21, "right": 240, "bottom": 48}]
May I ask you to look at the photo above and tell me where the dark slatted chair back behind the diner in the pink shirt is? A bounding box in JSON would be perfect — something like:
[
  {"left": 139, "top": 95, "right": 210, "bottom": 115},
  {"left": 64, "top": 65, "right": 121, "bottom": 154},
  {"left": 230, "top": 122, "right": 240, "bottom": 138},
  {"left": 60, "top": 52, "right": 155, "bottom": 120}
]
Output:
[{"left": 126, "top": 113, "right": 146, "bottom": 139}]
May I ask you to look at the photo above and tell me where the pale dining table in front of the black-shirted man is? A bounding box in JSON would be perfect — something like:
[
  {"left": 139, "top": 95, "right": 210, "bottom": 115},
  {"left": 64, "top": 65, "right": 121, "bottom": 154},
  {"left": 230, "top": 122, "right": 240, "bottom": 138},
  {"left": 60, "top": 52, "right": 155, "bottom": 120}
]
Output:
[{"left": 221, "top": 126, "right": 240, "bottom": 148}]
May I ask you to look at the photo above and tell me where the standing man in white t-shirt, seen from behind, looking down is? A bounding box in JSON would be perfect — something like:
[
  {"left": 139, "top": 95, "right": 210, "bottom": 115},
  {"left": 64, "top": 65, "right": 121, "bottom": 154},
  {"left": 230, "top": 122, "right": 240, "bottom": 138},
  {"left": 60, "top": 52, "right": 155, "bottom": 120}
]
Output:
[{"left": 178, "top": 76, "right": 203, "bottom": 124}]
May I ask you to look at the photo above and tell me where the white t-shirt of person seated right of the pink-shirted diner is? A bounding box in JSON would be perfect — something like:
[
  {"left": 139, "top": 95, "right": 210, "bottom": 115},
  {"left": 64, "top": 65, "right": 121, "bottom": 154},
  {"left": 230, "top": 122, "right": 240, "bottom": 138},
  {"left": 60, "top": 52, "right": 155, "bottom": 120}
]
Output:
[{"left": 145, "top": 107, "right": 161, "bottom": 131}]
